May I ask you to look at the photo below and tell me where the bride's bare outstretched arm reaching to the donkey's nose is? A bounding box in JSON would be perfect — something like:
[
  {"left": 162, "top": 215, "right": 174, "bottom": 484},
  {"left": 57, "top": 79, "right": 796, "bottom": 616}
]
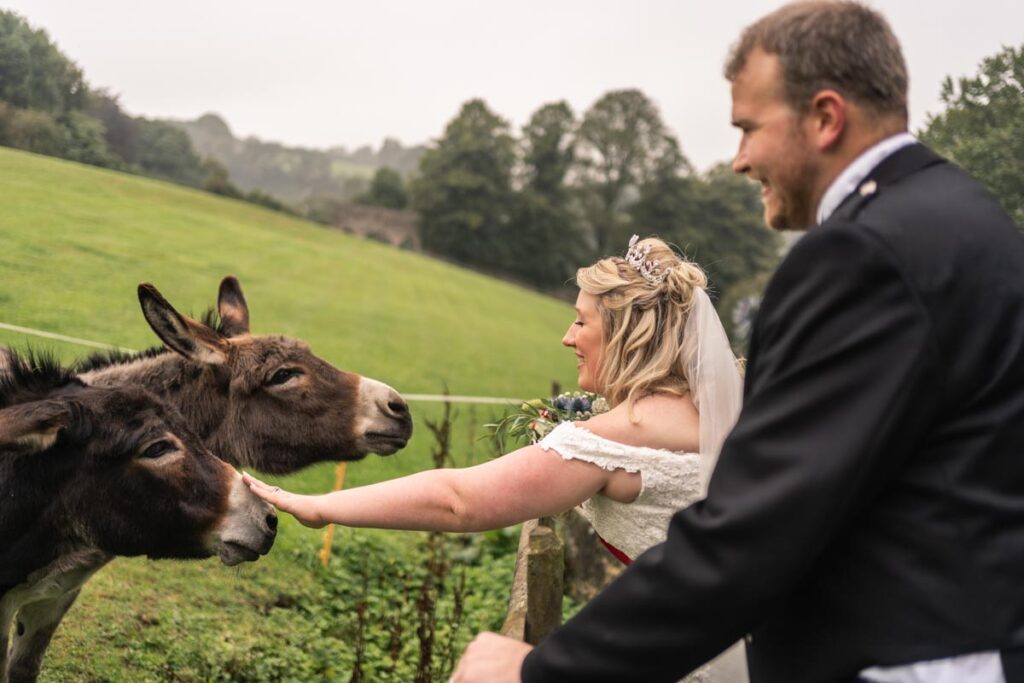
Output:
[{"left": 245, "top": 445, "right": 622, "bottom": 531}]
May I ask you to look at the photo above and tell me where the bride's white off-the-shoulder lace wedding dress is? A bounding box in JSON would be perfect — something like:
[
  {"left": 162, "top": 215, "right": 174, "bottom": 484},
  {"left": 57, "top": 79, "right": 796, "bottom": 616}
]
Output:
[{"left": 538, "top": 422, "right": 748, "bottom": 683}]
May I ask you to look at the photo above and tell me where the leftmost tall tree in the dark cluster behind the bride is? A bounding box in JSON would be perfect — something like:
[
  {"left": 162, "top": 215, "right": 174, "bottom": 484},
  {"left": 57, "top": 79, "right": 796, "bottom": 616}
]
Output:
[{"left": 413, "top": 99, "right": 515, "bottom": 267}]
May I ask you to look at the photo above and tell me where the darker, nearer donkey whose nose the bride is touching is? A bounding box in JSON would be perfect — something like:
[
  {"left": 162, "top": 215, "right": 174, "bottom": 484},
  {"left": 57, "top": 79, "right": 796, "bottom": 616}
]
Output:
[{"left": 0, "top": 353, "right": 278, "bottom": 683}]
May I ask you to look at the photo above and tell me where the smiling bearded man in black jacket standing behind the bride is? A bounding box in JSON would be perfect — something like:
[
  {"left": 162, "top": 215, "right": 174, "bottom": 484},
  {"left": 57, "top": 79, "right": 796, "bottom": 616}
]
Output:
[{"left": 453, "top": 1, "right": 1024, "bottom": 683}]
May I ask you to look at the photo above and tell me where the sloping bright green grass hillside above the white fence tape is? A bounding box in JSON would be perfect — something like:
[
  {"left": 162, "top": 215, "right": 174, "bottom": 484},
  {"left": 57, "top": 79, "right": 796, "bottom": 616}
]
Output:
[{"left": 0, "top": 148, "right": 574, "bottom": 396}]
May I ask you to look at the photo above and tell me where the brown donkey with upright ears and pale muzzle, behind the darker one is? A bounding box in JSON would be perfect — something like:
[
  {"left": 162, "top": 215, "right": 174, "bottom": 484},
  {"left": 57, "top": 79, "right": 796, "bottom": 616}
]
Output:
[{"left": 76, "top": 276, "right": 413, "bottom": 474}]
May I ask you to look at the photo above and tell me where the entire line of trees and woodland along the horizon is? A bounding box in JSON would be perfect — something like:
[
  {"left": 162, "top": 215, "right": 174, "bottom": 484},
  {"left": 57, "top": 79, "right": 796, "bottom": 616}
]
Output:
[{"left": 0, "top": 10, "right": 1024, "bottom": 338}]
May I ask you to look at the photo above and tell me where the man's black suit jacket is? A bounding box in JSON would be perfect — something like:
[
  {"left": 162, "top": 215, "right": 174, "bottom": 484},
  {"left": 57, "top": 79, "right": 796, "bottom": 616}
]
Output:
[{"left": 522, "top": 144, "right": 1024, "bottom": 683}]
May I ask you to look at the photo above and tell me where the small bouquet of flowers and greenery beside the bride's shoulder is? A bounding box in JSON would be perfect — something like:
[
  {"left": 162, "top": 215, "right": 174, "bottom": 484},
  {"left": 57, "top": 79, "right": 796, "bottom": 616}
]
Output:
[{"left": 485, "top": 391, "right": 608, "bottom": 452}]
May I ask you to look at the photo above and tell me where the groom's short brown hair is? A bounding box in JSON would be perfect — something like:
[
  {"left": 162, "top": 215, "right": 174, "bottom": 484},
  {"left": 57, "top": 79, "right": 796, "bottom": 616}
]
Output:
[{"left": 725, "top": 0, "right": 907, "bottom": 121}]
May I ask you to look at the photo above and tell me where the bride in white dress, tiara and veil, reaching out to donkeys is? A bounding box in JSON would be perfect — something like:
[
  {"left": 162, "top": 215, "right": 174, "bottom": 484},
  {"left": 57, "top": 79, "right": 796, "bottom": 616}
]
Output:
[{"left": 245, "top": 236, "right": 746, "bottom": 683}]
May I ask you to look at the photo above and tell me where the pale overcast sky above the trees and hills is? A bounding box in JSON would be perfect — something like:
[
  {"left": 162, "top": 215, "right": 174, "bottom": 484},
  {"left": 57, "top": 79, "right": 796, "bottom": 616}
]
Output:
[{"left": 8, "top": 0, "right": 1024, "bottom": 170}]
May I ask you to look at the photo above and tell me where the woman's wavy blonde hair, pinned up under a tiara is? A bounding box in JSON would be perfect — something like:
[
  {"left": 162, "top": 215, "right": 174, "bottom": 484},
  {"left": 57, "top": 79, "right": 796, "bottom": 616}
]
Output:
[{"left": 577, "top": 238, "right": 708, "bottom": 419}]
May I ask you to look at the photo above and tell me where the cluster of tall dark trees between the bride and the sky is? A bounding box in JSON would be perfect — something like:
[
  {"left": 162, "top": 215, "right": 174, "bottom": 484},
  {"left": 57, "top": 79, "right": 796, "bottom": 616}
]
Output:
[{"left": 410, "top": 89, "right": 779, "bottom": 315}]
